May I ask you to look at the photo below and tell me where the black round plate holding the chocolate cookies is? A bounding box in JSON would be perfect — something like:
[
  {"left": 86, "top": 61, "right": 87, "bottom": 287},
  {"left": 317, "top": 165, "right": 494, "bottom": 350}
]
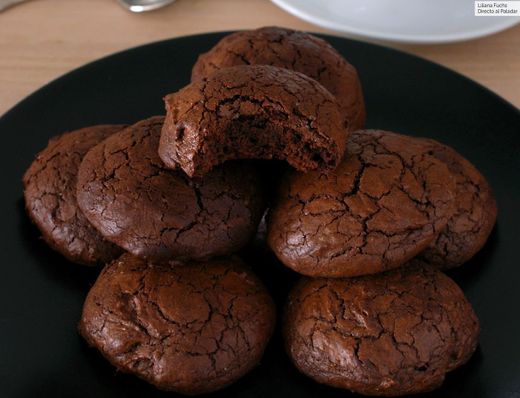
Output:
[{"left": 0, "top": 33, "right": 520, "bottom": 398}]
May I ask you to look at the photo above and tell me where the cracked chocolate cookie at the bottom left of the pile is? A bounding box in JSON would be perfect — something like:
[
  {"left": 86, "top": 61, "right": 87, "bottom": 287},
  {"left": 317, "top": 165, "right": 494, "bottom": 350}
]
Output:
[{"left": 79, "top": 254, "right": 275, "bottom": 394}]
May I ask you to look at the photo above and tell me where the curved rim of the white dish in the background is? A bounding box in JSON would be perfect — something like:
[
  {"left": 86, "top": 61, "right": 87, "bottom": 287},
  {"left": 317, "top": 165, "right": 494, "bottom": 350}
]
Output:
[{"left": 271, "top": 0, "right": 520, "bottom": 44}]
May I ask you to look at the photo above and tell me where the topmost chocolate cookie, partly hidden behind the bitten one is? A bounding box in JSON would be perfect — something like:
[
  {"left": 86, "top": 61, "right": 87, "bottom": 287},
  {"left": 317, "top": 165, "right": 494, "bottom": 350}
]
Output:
[{"left": 191, "top": 27, "right": 365, "bottom": 130}]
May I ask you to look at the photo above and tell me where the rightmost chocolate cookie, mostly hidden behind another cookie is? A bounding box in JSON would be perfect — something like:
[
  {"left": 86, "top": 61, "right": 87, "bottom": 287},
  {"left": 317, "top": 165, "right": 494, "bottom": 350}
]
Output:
[{"left": 420, "top": 140, "right": 497, "bottom": 269}]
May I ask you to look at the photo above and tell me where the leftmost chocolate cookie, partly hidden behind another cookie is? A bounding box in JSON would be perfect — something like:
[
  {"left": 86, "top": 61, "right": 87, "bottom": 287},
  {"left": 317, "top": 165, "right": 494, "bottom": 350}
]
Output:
[{"left": 23, "top": 125, "right": 124, "bottom": 265}]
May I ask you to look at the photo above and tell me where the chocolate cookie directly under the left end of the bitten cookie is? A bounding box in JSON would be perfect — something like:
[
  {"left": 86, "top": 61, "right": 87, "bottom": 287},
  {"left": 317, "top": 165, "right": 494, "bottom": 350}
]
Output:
[{"left": 77, "top": 117, "right": 264, "bottom": 259}]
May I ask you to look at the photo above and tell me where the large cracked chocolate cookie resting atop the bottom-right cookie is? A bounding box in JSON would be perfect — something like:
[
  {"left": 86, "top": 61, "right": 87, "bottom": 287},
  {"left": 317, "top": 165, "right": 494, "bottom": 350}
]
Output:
[{"left": 267, "top": 130, "right": 455, "bottom": 277}]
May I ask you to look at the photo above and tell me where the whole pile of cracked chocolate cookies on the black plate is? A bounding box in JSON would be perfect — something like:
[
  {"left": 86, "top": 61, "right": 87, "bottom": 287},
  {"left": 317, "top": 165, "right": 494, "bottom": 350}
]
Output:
[{"left": 24, "top": 28, "right": 497, "bottom": 396}]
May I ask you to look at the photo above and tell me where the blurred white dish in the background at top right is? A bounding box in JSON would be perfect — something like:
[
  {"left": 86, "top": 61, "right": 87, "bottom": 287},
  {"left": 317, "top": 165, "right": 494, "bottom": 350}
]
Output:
[{"left": 271, "top": 0, "right": 520, "bottom": 43}]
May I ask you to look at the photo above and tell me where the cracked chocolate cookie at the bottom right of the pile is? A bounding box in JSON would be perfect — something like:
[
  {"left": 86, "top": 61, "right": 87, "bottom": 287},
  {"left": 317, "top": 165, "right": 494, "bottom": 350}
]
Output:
[{"left": 284, "top": 267, "right": 479, "bottom": 396}]
